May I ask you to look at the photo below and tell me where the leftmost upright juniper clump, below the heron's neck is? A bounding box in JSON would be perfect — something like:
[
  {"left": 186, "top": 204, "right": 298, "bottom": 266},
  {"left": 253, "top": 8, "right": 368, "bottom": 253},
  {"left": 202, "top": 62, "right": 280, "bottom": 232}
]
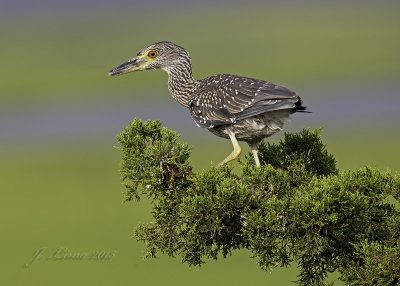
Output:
[{"left": 117, "top": 118, "right": 191, "bottom": 201}]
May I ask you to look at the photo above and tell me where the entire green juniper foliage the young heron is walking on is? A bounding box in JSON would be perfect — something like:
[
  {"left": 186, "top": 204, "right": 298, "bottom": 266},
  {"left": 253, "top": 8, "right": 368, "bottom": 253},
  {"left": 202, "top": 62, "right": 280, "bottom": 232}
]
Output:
[{"left": 117, "top": 119, "right": 400, "bottom": 285}]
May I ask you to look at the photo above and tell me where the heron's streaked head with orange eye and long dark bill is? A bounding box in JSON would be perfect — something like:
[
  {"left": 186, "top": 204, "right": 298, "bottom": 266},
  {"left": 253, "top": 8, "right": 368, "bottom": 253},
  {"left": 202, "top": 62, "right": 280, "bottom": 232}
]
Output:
[{"left": 108, "top": 42, "right": 190, "bottom": 76}]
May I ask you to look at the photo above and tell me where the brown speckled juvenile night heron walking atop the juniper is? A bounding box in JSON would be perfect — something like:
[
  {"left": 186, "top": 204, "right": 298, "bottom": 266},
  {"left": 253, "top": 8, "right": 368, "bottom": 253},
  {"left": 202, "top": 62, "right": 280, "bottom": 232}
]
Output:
[{"left": 108, "top": 42, "right": 305, "bottom": 166}]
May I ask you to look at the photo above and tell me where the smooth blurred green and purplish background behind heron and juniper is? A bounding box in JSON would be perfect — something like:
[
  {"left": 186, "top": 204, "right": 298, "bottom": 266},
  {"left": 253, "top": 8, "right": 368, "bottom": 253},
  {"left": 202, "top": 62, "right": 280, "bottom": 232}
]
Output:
[{"left": 0, "top": 0, "right": 400, "bottom": 285}]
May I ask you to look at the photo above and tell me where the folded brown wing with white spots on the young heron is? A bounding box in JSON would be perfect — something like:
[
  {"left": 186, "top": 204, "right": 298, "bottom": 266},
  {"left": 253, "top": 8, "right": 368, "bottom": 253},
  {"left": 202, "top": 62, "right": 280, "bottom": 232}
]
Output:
[{"left": 190, "top": 74, "right": 301, "bottom": 128}]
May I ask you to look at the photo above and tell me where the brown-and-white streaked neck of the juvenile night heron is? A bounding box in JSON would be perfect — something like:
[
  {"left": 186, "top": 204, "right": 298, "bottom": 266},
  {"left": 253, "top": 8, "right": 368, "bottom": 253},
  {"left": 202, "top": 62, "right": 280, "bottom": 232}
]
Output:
[{"left": 165, "top": 59, "right": 198, "bottom": 107}]
